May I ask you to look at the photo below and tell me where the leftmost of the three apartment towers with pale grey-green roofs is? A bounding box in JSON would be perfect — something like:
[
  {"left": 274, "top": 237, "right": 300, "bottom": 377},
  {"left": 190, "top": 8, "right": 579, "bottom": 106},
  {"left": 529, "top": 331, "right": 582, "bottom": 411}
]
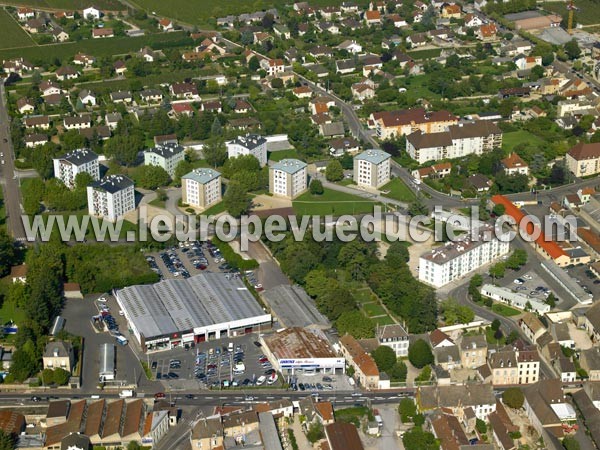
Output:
[{"left": 181, "top": 168, "right": 221, "bottom": 208}]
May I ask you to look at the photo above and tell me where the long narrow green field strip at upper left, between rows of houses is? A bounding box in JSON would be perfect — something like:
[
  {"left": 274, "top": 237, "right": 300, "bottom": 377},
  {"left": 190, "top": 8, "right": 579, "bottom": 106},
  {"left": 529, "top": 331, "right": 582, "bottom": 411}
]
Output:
[{"left": 0, "top": 32, "right": 192, "bottom": 63}]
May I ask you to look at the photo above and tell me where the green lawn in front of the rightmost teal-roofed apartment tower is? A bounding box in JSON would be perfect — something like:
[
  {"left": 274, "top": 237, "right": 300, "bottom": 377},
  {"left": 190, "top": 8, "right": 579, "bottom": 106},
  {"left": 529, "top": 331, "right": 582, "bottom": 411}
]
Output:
[{"left": 292, "top": 189, "right": 375, "bottom": 216}]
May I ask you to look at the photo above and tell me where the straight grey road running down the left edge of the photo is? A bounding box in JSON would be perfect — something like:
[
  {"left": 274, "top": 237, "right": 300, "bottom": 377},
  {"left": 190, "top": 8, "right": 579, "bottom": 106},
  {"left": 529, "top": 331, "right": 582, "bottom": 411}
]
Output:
[{"left": 0, "top": 83, "right": 26, "bottom": 240}]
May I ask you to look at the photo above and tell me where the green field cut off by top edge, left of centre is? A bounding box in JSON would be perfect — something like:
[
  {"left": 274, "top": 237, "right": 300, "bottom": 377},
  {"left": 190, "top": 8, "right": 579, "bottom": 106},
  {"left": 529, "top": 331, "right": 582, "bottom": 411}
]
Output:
[{"left": 130, "top": 0, "right": 352, "bottom": 24}]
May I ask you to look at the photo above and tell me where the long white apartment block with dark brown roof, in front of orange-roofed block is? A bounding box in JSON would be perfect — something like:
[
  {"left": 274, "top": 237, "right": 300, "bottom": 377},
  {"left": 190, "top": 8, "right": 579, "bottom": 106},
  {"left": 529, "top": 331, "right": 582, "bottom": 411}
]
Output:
[{"left": 406, "top": 120, "right": 502, "bottom": 164}]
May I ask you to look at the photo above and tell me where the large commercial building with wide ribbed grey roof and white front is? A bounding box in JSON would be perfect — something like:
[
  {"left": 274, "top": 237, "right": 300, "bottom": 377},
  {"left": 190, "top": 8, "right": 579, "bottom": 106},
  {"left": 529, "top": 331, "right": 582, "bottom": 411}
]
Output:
[{"left": 114, "top": 273, "right": 271, "bottom": 351}]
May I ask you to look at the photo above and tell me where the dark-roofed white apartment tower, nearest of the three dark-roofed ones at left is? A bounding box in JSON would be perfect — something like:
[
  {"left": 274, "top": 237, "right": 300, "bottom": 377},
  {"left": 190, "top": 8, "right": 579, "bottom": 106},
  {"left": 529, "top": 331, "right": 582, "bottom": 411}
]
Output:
[{"left": 87, "top": 175, "right": 135, "bottom": 222}]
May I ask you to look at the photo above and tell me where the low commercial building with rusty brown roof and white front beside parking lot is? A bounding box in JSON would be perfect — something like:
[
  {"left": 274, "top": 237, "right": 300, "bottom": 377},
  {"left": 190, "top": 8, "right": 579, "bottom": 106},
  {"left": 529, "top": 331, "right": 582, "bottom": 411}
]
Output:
[{"left": 261, "top": 327, "right": 346, "bottom": 375}]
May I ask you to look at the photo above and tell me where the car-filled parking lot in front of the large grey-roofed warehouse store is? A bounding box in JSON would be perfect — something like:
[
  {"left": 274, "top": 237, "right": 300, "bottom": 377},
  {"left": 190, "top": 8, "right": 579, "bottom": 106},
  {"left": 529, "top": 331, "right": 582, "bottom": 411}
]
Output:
[{"left": 148, "top": 334, "right": 280, "bottom": 389}]
